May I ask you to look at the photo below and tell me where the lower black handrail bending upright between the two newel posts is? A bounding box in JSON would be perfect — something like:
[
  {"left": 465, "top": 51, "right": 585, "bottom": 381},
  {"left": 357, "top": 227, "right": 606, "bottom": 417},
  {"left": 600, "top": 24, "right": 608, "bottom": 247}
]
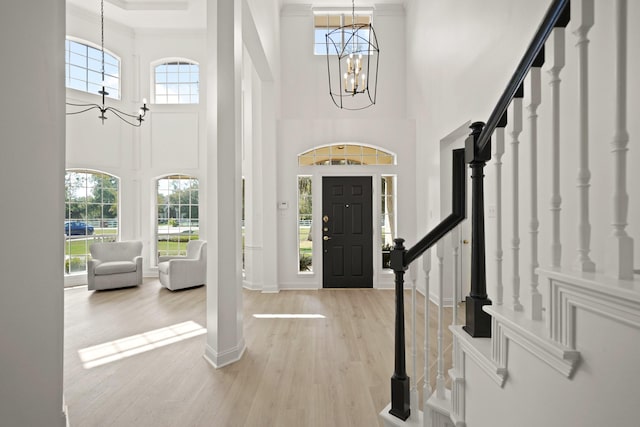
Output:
[{"left": 404, "top": 148, "right": 467, "bottom": 266}]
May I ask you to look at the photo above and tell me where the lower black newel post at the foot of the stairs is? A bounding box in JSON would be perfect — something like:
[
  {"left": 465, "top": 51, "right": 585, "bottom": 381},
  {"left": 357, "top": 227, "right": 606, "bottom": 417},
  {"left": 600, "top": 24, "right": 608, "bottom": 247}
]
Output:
[{"left": 389, "top": 239, "right": 411, "bottom": 421}]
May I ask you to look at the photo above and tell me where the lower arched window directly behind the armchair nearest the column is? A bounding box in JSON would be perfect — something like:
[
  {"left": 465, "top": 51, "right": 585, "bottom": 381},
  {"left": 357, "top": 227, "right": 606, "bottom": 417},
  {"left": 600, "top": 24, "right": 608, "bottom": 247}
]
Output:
[{"left": 156, "top": 175, "right": 200, "bottom": 256}]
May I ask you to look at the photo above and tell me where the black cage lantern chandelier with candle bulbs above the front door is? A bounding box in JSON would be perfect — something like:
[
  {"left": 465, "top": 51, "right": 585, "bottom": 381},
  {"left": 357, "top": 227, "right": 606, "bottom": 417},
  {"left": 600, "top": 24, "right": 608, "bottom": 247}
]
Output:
[{"left": 325, "top": 0, "right": 380, "bottom": 110}]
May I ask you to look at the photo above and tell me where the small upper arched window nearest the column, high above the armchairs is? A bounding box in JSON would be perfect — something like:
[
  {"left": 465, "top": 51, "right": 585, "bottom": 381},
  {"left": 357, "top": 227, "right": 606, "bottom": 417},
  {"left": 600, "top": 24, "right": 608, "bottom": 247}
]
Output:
[{"left": 155, "top": 61, "right": 200, "bottom": 104}]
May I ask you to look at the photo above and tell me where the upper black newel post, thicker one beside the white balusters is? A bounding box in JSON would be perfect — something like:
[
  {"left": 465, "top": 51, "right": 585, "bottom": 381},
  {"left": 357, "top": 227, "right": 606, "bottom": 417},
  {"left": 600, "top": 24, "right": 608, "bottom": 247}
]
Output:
[{"left": 464, "top": 122, "right": 491, "bottom": 337}]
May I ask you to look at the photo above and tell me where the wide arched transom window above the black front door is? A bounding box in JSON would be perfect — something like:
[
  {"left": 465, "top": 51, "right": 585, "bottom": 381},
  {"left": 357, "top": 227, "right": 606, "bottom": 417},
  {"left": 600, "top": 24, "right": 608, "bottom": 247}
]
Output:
[{"left": 298, "top": 144, "right": 396, "bottom": 166}]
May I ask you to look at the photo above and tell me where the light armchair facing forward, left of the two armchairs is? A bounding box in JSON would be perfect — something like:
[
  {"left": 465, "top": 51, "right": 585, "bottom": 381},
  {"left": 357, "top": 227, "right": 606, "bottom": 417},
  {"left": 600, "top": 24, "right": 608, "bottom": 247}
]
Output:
[{"left": 87, "top": 241, "right": 142, "bottom": 291}]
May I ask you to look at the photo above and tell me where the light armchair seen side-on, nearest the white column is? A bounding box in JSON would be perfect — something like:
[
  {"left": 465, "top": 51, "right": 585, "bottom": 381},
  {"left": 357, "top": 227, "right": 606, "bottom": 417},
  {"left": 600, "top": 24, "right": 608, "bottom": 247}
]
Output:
[{"left": 158, "top": 240, "right": 207, "bottom": 291}]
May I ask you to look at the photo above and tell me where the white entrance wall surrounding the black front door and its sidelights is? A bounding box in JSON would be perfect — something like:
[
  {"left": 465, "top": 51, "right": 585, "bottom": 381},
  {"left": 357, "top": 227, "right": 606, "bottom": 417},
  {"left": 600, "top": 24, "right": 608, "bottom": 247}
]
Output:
[{"left": 277, "top": 5, "right": 417, "bottom": 289}]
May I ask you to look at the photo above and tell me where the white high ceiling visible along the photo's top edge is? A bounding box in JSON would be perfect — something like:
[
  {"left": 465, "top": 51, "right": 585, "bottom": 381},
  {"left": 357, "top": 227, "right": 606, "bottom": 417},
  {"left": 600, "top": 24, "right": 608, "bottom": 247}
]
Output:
[{"left": 66, "top": 0, "right": 405, "bottom": 29}]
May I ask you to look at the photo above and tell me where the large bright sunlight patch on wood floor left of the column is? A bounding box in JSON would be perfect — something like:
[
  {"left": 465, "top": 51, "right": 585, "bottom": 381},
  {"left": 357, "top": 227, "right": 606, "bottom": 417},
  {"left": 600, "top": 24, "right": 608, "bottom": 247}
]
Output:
[{"left": 78, "top": 320, "right": 207, "bottom": 369}]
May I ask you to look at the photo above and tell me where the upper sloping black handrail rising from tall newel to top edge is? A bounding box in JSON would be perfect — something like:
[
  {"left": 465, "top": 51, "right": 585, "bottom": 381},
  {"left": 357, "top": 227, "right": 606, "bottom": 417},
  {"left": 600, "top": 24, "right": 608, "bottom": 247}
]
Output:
[{"left": 477, "top": 0, "right": 569, "bottom": 150}]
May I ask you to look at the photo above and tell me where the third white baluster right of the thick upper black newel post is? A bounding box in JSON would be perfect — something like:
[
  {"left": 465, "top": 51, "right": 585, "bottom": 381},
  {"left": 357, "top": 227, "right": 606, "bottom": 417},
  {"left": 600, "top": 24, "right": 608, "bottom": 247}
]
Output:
[{"left": 528, "top": 64, "right": 542, "bottom": 320}]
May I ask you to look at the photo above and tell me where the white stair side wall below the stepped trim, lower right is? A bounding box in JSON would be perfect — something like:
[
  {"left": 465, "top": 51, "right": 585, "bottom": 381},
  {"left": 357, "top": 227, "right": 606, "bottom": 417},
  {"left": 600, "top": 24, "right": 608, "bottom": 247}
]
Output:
[{"left": 458, "top": 298, "right": 640, "bottom": 427}]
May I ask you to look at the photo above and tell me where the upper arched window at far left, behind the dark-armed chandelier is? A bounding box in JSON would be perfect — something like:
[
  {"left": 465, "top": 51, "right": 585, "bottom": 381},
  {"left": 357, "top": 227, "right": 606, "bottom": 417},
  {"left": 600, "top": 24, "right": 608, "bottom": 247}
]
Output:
[{"left": 65, "top": 39, "right": 120, "bottom": 99}]
